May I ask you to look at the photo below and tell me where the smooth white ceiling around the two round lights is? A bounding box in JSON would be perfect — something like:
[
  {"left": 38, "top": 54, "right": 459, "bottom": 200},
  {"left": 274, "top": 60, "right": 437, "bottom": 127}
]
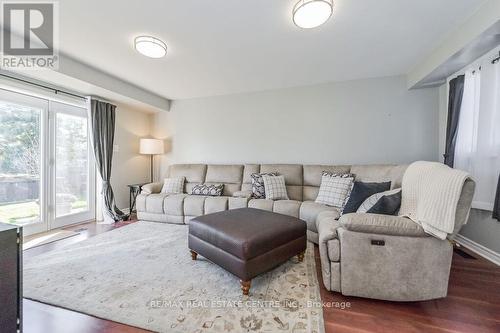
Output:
[{"left": 59, "top": 0, "right": 485, "bottom": 99}]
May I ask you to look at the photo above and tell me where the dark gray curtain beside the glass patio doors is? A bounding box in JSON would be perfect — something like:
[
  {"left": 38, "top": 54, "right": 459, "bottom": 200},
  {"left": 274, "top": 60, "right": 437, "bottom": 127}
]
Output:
[{"left": 90, "top": 99, "right": 128, "bottom": 222}]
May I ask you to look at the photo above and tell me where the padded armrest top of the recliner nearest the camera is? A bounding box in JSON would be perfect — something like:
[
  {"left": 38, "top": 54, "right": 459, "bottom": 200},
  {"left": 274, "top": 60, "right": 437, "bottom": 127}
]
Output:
[{"left": 339, "top": 213, "right": 427, "bottom": 237}]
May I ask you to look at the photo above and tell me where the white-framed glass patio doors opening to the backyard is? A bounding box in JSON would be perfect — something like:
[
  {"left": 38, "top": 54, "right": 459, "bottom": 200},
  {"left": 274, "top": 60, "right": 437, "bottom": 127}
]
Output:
[{"left": 0, "top": 89, "right": 95, "bottom": 234}]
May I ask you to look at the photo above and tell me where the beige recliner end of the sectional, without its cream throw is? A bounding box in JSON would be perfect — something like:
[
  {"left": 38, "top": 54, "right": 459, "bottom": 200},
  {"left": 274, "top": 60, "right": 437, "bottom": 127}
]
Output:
[{"left": 316, "top": 179, "right": 475, "bottom": 301}]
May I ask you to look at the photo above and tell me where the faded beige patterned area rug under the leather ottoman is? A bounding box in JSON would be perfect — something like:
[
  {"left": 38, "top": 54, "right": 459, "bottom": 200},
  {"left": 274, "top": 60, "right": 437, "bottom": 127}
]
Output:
[{"left": 23, "top": 221, "right": 324, "bottom": 333}]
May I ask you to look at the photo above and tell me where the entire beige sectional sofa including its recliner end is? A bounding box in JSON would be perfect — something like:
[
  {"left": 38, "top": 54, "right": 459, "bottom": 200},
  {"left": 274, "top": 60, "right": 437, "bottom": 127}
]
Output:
[{"left": 137, "top": 164, "right": 475, "bottom": 301}]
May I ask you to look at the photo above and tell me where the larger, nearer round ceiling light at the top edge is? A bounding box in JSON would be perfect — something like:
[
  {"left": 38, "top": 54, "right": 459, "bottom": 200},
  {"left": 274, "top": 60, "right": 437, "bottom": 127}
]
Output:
[{"left": 293, "top": 0, "right": 333, "bottom": 29}]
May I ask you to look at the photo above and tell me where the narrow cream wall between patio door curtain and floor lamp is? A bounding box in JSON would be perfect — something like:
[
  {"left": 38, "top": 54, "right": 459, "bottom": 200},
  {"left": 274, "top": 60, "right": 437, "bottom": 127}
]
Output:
[{"left": 111, "top": 105, "right": 152, "bottom": 208}]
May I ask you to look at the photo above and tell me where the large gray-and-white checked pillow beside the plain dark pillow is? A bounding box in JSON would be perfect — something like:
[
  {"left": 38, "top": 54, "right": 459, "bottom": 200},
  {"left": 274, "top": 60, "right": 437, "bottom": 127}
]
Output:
[{"left": 316, "top": 171, "right": 354, "bottom": 211}]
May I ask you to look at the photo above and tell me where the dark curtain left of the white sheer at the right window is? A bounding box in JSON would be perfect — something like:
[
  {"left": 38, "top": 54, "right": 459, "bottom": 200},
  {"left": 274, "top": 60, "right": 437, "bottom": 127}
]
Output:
[{"left": 444, "top": 75, "right": 465, "bottom": 168}]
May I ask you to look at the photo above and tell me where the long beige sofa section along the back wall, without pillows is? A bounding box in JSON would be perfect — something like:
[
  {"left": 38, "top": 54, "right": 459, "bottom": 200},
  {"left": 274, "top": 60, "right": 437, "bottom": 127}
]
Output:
[{"left": 137, "top": 164, "right": 406, "bottom": 244}]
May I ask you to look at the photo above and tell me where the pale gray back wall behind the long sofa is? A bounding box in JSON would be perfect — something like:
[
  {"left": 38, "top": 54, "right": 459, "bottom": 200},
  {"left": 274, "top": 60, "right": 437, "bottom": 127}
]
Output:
[{"left": 153, "top": 76, "right": 439, "bottom": 172}]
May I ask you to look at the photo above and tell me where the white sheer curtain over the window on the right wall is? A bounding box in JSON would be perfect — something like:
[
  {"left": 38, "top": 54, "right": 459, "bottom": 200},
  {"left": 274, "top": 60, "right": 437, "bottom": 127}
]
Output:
[{"left": 454, "top": 56, "right": 500, "bottom": 210}]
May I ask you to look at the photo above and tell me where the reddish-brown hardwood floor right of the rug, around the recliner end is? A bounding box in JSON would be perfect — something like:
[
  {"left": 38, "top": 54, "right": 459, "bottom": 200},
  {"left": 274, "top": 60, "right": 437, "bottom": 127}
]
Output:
[{"left": 315, "top": 248, "right": 500, "bottom": 333}]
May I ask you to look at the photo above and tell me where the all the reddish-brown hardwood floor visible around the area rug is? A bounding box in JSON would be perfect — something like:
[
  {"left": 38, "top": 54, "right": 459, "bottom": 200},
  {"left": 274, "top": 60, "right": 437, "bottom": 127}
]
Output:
[{"left": 23, "top": 221, "right": 500, "bottom": 333}]
